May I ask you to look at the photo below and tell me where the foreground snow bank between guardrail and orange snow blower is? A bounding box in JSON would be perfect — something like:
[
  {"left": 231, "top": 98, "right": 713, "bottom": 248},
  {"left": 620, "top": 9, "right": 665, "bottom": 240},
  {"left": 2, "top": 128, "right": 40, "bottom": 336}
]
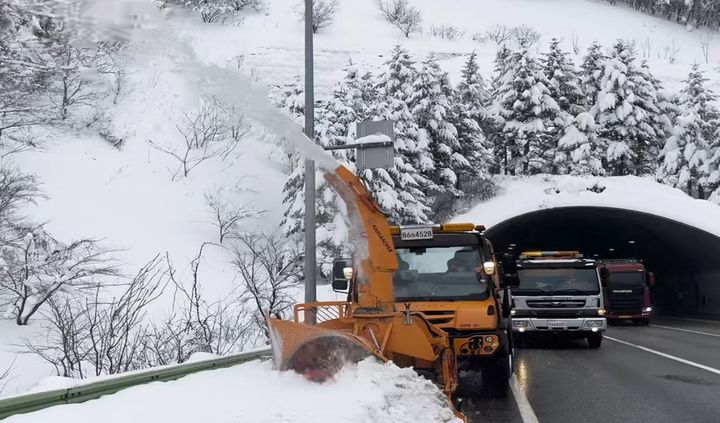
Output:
[{"left": 6, "top": 359, "right": 459, "bottom": 423}]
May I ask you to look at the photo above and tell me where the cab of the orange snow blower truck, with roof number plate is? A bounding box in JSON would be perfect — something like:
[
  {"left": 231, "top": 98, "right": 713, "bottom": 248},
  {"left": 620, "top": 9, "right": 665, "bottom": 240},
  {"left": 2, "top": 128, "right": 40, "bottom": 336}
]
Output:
[{"left": 335, "top": 223, "right": 513, "bottom": 386}]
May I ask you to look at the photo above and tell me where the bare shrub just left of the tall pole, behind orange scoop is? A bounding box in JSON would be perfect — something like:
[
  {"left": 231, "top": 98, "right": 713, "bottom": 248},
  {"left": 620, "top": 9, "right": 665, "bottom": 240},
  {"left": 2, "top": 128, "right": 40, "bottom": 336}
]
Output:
[{"left": 233, "top": 233, "right": 302, "bottom": 334}]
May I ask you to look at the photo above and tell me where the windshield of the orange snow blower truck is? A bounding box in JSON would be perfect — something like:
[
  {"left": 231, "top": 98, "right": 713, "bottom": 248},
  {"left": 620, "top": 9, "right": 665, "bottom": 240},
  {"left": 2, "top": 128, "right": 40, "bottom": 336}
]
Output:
[{"left": 393, "top": 247, "right": 488, "bottom": 301}]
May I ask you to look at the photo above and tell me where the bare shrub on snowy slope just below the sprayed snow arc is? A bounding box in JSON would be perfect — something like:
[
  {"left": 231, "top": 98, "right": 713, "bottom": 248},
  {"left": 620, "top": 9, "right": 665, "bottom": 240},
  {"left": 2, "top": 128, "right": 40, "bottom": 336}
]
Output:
[{"left": 149, "top": 97, "right": 249, "bottom": 180}]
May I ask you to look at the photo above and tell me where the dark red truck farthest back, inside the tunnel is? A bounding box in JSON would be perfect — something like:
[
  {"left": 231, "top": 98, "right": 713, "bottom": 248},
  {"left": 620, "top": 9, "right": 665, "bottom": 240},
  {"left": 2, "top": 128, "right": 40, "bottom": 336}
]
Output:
[{"left": 601, "top": 259, "right": 655, "bottom": 325}]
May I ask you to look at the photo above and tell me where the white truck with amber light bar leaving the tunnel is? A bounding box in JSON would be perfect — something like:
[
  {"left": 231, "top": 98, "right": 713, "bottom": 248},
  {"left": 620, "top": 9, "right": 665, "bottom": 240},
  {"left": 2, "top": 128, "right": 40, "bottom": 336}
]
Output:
[{"left": 510, "top": 251, "right": 607, "bottom": 348}]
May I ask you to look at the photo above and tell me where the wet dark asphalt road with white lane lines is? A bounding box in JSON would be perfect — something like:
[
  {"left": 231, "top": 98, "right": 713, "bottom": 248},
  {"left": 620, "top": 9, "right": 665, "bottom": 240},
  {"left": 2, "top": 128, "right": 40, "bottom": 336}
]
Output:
[{"left": 461, "top": 319, "right": 720, "bottom": 423}]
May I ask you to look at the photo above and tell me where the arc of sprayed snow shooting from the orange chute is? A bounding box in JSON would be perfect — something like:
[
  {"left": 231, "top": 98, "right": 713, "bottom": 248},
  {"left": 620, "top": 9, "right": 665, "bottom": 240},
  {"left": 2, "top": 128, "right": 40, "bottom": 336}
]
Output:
[{"left": 67, "top": 0, "right": 340, "bottom": 172}]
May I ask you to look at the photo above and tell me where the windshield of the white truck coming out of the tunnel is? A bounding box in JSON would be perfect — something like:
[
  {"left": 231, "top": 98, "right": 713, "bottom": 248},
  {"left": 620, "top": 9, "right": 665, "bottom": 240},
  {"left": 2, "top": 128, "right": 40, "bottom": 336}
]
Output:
[{"left": 513, "top": 267, "right": 600, "bottom": 295}]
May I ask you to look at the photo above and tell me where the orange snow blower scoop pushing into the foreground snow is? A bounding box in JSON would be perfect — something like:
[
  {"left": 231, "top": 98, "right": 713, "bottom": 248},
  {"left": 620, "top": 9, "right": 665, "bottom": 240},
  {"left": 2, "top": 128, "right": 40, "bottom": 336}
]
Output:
[{"left": 267, "top": 318, "right": 387, "bottom": 382}]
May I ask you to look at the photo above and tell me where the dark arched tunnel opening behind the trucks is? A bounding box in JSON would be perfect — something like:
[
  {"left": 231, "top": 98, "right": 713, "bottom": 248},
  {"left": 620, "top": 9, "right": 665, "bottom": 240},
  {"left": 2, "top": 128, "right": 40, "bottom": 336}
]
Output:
[{"left": 485, "top": 207, "right": 720, "bottom": 317}]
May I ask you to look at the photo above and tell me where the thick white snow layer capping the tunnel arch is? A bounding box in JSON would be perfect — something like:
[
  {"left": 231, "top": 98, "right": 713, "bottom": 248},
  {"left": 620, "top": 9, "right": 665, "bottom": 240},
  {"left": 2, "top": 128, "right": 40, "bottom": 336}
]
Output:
[{"left": 454, "top": 175, "right": 720, "bottom": 236}]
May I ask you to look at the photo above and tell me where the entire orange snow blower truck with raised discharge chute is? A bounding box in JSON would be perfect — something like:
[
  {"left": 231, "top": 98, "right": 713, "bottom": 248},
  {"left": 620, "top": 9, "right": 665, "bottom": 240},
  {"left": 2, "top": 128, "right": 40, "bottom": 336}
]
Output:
[{"left": 268, "top": 166, "right": 515, "bottom": 418}]
